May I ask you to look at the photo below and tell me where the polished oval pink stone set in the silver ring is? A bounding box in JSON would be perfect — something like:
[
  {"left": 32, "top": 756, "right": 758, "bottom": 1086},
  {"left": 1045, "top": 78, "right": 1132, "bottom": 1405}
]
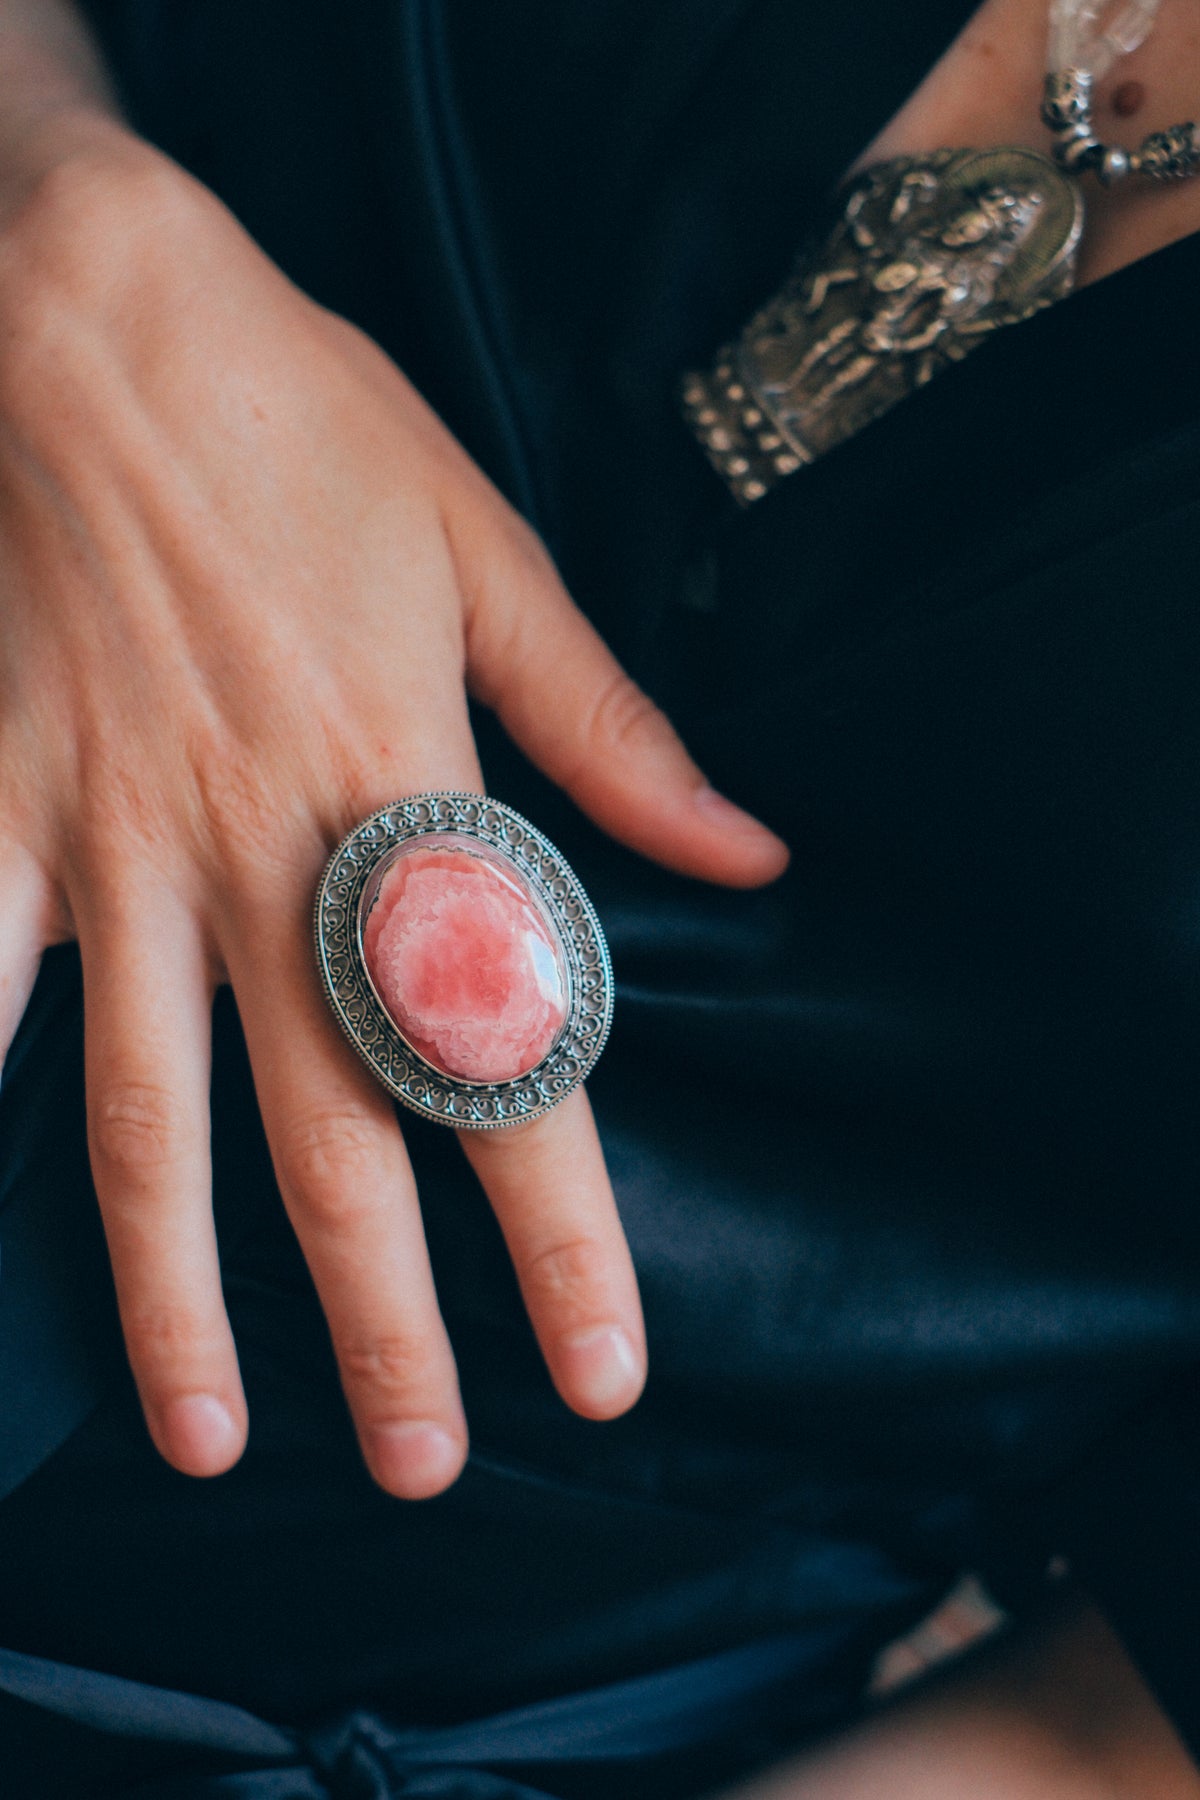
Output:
[{"left": 363, "top": 842, "right": 567, "bottom": 1082}]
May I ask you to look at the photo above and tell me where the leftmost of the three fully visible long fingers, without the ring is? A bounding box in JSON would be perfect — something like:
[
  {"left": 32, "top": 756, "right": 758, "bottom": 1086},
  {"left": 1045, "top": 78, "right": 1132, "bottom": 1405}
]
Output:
[{"left": 77, "top": 884, "right": 246, "bottom": 1476}]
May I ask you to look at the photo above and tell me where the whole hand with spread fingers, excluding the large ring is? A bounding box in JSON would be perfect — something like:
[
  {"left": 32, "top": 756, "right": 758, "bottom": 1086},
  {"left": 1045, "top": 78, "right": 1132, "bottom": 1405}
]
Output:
[{"left": 0, "top": 110, "right": 786, "bottom": 1498}]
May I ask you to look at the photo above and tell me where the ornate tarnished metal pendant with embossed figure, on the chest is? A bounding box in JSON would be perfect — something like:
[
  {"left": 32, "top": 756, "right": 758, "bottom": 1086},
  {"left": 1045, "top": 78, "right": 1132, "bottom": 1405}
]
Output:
[{"left": 682, "top": 144, "right": 1083, "bottom": 506}]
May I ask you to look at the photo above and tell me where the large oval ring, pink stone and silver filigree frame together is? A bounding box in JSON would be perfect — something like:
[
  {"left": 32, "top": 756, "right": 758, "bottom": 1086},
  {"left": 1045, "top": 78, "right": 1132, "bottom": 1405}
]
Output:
[{"left": 315, "top": 794, "right": 612, "bottom": 1130}]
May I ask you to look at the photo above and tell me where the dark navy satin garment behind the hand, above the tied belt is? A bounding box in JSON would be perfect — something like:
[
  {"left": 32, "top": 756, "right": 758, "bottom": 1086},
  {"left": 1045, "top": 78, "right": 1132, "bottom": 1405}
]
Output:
[{"left": 0, "top": 0, "right": 1200, "bottom": 1795}]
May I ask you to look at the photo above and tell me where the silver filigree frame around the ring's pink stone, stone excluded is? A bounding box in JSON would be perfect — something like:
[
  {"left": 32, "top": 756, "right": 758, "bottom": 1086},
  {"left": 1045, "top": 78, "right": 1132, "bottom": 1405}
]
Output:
[{"left": 315, "top": 794, "right": 613, "bottom": 1130}]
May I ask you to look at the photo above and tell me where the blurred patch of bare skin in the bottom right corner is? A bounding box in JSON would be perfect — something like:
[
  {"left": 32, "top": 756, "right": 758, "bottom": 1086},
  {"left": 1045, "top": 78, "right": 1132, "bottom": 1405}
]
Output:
[{"left": 729, "top": 1606, "right": 1200, "bottom": 1800}]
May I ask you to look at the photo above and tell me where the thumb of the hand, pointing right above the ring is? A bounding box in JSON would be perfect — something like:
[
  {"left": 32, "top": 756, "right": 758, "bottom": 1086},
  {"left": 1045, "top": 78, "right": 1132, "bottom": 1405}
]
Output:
[{"left": 455, "top": 522, "right": 788, "bottom": 887}]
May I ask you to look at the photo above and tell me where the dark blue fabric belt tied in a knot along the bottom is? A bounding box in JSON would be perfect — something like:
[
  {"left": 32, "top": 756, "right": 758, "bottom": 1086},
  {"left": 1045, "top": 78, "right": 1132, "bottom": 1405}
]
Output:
[{"left": 0, "top": 1620, "right": 858, "bottom": 1800}]
